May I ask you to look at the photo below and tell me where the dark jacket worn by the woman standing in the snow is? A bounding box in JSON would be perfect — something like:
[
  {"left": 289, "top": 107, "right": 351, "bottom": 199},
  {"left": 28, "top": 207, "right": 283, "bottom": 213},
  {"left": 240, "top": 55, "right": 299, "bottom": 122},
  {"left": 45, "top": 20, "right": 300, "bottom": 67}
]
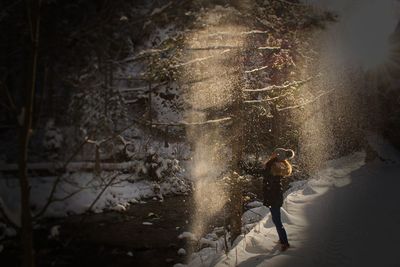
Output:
[{"left": 263, "top": 159, "right": 283, "bottom": 207}]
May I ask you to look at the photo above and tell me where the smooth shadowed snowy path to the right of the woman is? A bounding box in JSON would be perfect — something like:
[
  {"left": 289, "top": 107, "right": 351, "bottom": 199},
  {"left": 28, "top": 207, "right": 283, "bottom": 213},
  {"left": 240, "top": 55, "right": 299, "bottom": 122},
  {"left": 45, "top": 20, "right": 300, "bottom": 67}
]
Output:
[{"left": 268, "top": 161, "right": 400, "bottom": 266}]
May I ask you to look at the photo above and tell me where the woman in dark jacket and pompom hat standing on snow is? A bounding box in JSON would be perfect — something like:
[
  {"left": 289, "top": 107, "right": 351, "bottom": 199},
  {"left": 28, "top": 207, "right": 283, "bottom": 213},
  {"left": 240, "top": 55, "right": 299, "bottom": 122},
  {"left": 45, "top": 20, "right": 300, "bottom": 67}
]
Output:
[{"left": 263, "top": 148, "right": 294, "bottom": 251}]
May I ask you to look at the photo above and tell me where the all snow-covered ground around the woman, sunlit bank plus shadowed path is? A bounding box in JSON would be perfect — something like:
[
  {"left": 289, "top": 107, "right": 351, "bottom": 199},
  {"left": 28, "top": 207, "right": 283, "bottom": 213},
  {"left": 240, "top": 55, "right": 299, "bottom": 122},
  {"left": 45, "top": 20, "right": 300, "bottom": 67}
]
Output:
[{"left": 189, "top": 136, "right": 400, "bottom": 267}]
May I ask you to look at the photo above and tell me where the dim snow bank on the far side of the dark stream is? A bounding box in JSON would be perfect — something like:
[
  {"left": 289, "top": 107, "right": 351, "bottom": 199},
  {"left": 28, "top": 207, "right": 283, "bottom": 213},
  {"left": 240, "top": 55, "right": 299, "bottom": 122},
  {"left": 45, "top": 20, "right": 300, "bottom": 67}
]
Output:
[{"left": 0, "top": 172, "right": 190, "bottom": 220}]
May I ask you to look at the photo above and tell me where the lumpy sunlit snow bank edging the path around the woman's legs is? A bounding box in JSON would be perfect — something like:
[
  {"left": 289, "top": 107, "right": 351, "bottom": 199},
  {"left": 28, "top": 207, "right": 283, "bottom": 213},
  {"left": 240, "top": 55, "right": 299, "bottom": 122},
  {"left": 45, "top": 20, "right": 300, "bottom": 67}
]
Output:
[{"left": 188, "top": 152, "right": 365, "bottom": 267}]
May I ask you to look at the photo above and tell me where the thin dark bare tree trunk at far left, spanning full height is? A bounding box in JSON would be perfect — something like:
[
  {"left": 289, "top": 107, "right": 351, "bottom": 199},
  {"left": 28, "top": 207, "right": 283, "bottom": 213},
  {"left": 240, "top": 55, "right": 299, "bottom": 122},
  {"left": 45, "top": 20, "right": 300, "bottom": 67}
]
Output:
[{"left": 19, "top": 0, "right": 40, "bottom": 267}]
